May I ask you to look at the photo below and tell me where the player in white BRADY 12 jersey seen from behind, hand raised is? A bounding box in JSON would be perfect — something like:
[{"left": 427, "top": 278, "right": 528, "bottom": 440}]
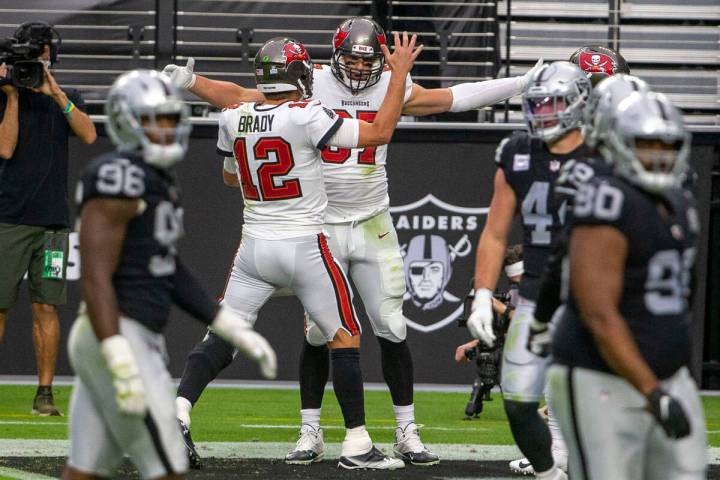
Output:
[{"left": 186, "top": 34, "right": 422, "bottom": 469}]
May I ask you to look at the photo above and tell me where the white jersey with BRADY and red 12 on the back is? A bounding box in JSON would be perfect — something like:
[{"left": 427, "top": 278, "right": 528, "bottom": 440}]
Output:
[{"left": 217, "top": 101, "right": 342, "bottom": 239}]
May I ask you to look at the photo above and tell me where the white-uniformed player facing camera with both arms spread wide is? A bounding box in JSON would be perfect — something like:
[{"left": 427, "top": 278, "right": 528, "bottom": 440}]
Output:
[{"left": 165, "top": 18, "right": 540, "bottom": 465}]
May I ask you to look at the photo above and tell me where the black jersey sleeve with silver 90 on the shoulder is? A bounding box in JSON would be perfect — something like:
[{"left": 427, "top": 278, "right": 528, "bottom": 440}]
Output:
[{"left": 571, "top": 177, "right": 632, "bottom": 231}]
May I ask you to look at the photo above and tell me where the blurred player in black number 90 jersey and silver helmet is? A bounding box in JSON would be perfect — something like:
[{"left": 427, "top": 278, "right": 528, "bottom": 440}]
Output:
[{"left": 548, "top": 92, "right": 706, "bottom": 480}]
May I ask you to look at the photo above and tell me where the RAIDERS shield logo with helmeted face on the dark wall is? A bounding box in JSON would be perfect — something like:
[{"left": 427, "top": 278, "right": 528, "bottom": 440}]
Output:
[{"left": 390, "top": 194, "right": 488, "bottom": 333}]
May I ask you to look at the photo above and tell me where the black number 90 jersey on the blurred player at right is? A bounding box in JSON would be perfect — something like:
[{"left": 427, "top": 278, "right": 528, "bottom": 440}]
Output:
[{"left": 553, "top": 176, "right": 699, "bottom": 379}]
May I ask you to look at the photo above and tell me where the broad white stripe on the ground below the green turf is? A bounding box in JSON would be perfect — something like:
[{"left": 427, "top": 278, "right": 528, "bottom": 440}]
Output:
[{"left": 0, "top": 439, "right": 720, "bottom": 464}]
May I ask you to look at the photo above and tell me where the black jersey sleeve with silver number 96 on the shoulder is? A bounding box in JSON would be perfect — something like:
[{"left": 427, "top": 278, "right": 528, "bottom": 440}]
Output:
[{"left": 76, "top": 157, "right": 146, "bottom": 206}]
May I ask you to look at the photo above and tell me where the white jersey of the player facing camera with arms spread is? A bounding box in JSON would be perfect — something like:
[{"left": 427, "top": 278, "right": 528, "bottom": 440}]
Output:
[{"left": 312, "top": 65, "right": 413, "bottom": 223}]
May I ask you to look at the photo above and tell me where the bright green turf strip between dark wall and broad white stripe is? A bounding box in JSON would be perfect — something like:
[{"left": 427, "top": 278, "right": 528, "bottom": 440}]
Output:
[{"left": 0, "top": 386, "right": 720, "bottom": 447}]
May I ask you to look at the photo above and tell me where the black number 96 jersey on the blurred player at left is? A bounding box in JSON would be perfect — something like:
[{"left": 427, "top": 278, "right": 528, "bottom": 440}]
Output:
[{"left": 77, "top": 152, "right": 183, "bottom": 332}]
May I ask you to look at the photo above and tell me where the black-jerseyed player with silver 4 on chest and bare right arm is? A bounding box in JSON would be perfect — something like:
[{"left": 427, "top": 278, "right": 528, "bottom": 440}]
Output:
[{"left": 467, "top": 62, "right": 592, "bottom": 479}]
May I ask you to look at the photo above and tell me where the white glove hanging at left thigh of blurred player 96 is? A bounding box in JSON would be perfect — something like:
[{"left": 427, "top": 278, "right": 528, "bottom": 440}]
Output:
[{"left": 100, "top": 335, "right": 146, "bottom": 415}]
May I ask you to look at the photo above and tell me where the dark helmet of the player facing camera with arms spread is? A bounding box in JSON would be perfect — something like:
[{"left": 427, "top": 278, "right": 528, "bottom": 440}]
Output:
[{"left": 330, "top": 17, "right": 386, "bottom": 93}]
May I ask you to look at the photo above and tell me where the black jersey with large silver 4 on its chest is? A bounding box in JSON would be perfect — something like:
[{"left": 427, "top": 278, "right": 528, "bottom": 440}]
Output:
[{"left": 495, "top": 132, "right": 588, "bottom": 300}]
